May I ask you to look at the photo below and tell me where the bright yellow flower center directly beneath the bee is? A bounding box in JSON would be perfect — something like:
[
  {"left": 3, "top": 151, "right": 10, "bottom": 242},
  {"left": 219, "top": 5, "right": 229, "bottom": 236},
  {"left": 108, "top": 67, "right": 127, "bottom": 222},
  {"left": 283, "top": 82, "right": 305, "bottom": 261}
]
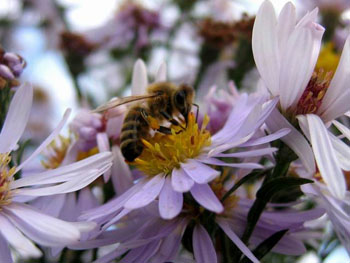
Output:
[{"left": 130, "top": 113, "right": 211, "bottom": 176}]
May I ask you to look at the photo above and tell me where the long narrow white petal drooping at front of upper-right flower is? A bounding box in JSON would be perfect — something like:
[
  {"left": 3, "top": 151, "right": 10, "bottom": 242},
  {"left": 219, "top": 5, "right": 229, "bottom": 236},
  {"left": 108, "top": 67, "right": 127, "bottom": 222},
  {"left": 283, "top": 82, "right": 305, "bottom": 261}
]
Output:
[{"left": 307, "top": 114, "right": 346, "bottom": 198}]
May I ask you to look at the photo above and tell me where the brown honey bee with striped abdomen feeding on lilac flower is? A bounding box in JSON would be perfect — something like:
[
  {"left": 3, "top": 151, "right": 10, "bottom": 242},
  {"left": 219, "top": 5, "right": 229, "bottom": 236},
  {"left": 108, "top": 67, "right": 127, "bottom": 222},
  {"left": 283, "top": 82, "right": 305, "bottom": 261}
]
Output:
[{"left": 94, "top": 82, "right": 198, "bottom": 162}]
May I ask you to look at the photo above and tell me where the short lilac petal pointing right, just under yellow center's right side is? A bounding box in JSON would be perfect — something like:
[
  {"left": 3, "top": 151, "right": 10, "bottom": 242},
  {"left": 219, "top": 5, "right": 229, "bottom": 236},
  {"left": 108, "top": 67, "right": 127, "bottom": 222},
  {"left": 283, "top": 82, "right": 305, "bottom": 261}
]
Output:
[{"left": 181, "top": 159, "right": 220, "bottom": 184}]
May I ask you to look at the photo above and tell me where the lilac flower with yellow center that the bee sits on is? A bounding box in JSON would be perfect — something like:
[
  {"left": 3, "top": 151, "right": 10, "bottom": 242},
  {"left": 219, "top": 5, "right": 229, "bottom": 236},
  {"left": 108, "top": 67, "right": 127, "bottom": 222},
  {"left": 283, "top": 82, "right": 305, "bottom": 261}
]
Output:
[{"left": 82, "top": 58, "right": 289, "bottom": 228}]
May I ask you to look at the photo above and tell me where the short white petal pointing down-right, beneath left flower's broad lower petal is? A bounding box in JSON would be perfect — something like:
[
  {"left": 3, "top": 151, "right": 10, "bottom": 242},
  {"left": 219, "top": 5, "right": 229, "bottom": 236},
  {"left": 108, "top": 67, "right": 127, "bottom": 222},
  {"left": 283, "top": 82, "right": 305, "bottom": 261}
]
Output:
[{"left": 0, "top": 216, "right": 42, "bottom": 259}]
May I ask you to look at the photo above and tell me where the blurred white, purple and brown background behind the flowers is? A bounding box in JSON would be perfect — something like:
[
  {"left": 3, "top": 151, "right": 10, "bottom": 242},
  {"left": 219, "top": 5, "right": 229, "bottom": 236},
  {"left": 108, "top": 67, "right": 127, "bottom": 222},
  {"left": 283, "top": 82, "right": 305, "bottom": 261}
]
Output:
[{"left": 0, "top": 0, "right": 350, "bottom": 263}]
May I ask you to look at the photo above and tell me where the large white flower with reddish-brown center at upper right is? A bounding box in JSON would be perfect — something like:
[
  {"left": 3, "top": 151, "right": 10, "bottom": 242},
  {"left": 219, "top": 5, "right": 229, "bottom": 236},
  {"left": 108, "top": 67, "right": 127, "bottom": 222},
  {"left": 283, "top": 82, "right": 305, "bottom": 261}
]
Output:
[{"left": 253, "top": 1, "right": 350, "bottom": 198}]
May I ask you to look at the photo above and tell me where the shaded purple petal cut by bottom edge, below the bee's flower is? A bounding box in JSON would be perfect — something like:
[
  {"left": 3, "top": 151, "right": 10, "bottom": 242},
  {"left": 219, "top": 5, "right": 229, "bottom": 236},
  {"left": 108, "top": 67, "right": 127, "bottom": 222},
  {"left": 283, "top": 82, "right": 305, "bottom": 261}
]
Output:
[{"left": 192, "top": 224, "right": 218, "bottom": 263}]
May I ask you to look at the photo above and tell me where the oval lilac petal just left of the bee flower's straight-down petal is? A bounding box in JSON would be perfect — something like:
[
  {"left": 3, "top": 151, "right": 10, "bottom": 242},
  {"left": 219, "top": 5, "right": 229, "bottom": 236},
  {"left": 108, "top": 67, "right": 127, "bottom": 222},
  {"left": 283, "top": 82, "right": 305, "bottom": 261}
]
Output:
[{"left": 124, "top": 174, "right": 165, "bottom": 210}]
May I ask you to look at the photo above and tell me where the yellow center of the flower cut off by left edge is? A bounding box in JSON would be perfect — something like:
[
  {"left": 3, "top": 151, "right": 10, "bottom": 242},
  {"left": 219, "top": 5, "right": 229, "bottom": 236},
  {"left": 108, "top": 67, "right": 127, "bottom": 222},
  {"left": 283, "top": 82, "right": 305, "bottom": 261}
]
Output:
[{"left": 0, "top": 153, "right": 16, "bottom": 210}]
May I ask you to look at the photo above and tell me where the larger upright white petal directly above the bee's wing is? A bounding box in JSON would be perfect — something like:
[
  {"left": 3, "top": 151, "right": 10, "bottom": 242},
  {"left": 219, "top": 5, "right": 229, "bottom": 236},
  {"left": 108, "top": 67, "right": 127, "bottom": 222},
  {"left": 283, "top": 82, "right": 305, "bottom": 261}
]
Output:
[{"left": 131, "top": 59, "right": 148, "bottom": 96}]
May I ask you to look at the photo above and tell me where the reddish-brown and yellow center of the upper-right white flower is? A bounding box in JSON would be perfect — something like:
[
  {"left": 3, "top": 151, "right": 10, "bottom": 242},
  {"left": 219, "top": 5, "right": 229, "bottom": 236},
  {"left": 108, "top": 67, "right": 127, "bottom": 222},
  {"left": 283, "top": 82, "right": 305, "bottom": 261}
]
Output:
[{"left": 296, "top": 70, "right": 332, "bottom": 115}]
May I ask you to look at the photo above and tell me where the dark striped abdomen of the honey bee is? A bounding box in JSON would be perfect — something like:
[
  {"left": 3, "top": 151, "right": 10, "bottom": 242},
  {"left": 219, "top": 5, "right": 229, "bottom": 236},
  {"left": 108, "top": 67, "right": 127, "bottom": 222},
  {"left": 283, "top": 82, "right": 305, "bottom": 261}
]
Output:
[{"left": 120, "top": 106, "right": 149, "bottom": 162}]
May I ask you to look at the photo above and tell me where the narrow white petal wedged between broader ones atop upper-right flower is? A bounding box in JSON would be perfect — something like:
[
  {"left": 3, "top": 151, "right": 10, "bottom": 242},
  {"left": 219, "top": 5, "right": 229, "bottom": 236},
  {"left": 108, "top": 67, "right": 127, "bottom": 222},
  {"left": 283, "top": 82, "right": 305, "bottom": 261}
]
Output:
[{"left": 277, "top": 2, "right": 296, "bottom": 57}]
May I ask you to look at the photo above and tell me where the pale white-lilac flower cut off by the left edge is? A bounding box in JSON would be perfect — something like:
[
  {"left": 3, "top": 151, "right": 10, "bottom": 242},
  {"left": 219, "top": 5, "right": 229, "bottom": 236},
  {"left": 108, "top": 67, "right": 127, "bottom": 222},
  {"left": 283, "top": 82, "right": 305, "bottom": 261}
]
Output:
[{"left": 0, "top": 85, "right": 111, "bottom": 263}]
